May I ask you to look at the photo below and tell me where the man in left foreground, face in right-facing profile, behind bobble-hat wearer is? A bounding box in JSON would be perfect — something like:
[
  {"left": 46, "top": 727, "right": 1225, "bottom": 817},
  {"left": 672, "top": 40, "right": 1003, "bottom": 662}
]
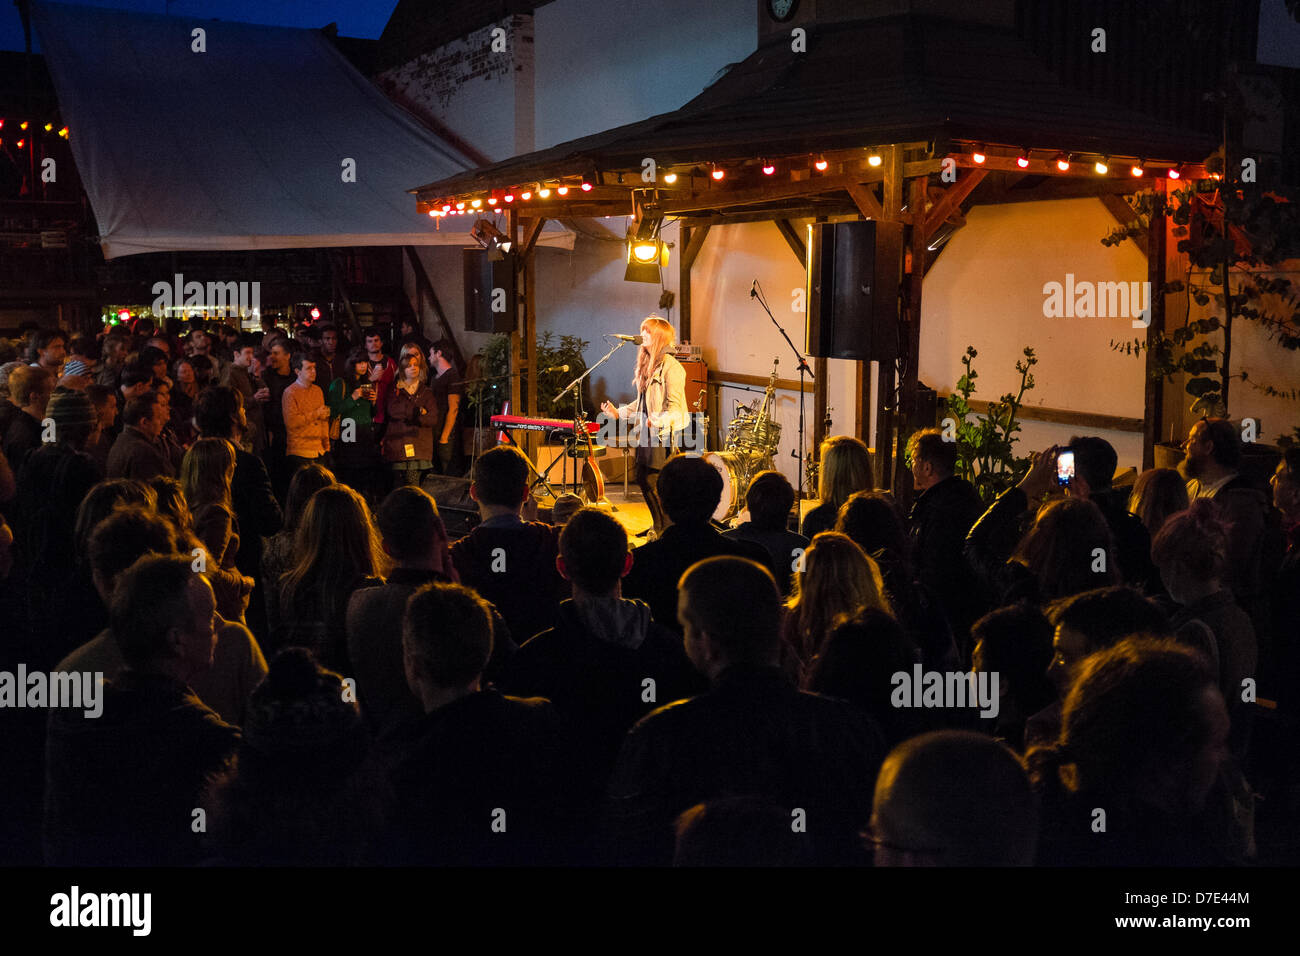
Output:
[{"left": 44, "top": 555, "right": 239, "bottom": 866}]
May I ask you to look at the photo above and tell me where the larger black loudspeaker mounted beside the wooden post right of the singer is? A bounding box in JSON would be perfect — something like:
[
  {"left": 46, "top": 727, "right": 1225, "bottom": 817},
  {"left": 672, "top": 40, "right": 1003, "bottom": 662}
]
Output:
[{"left": 805, "top": 220, "right": 902, "bottom": 362}]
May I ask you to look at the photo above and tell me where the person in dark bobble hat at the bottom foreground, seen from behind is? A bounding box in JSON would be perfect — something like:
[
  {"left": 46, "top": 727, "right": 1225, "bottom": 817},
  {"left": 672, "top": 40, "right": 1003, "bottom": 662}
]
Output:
[{"left": 202, "top": 648, "right": 378, "bottom": 866}]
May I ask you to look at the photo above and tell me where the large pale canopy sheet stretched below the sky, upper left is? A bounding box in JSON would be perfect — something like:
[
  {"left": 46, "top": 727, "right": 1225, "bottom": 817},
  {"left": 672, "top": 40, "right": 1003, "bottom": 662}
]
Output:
[{"left": 33, "top": 3, "right": 573, "bottom": 259}]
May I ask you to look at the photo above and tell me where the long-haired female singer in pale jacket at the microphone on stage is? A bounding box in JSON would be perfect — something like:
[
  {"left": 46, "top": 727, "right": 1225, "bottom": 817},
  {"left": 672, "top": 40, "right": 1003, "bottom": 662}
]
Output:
[{"left": 601, "top": 315, "right": 690, "bottom": 536}]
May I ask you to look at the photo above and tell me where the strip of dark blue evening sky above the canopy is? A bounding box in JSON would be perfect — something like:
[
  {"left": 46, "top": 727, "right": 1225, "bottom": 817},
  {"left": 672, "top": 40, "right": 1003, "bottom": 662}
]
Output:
[{"left": 0, "top": 0, "right": 398, "bottom": 52}]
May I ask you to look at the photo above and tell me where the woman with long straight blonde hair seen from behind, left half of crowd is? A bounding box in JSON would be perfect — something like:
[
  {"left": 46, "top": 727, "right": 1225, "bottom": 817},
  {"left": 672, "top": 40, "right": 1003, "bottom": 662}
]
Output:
[{"left": 267, "top": 485, "right": 387, "bottom": 674}]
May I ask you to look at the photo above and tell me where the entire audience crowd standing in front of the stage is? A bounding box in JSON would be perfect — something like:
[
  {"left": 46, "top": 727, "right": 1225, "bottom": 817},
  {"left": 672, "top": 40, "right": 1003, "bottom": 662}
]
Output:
[{"left": 0, "top": 323, "right": 1300, "bottom": 866}]
